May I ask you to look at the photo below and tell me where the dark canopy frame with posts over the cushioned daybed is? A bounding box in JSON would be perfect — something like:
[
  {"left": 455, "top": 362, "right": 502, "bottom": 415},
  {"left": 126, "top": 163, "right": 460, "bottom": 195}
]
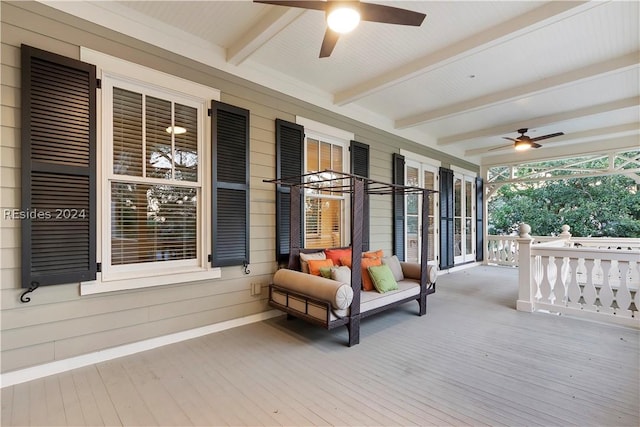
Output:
[{"left": 263, "top": 169, "right": 437, "bottom": 346}]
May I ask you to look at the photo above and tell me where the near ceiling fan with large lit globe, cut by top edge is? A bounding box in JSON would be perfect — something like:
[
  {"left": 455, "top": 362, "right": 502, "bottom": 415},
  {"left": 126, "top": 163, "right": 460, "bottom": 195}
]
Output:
[{"left": 253, "top": 0, "right": 427, "bottom": 58}]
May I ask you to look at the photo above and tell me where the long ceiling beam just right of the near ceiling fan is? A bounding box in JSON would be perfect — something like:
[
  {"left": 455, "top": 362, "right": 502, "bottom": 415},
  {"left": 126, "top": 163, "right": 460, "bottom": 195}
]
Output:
[{"left": 333, "top": 1, "right": 601, "bottom": 105}]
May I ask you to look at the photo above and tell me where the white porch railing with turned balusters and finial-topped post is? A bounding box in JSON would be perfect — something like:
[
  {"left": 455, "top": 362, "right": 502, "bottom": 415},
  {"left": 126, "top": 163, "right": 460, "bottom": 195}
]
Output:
[{"left": 516, "top": 224, "right": 640, "bottom": 328}]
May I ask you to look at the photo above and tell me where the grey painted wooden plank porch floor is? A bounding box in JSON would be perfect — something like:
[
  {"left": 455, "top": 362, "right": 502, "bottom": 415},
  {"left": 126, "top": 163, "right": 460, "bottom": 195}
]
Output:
[{"left": 1, "top": 267, "right": 640, "bottom": 426}]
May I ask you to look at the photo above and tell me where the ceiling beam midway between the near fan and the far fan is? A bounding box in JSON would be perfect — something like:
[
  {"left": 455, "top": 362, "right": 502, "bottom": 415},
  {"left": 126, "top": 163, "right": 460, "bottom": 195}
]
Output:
[{"left": 395, "top": 52, "right": 638, "bottom": 129}]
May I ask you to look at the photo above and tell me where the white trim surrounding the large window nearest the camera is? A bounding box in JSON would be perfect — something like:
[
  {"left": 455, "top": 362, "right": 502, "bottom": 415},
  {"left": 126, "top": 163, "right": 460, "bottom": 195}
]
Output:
[{"left": 80, "top": 47, "right": 221, "bottom": 295}]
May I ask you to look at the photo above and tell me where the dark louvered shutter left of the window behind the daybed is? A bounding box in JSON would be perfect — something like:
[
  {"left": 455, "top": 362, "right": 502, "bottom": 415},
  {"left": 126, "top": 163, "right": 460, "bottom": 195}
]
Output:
[{"left": 276, "top": 119, "right": 304, "bottom": 262}]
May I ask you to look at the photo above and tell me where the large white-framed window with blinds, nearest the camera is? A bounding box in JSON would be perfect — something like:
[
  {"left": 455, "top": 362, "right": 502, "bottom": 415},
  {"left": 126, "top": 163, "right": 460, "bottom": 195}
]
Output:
[{"left": 81, "top": 49, "right": 220, "bottom": 294}]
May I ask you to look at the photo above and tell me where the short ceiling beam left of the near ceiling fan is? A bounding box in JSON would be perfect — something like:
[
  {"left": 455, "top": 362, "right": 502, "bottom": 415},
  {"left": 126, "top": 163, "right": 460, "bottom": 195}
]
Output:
[{"left": 227, "top": 7, "right": 304, "bottom": 65}]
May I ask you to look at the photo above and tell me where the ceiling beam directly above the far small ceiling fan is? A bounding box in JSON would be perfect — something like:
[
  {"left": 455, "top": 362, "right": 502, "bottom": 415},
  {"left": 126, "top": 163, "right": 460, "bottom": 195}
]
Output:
[{"left": 437, "top": 96, "right": 640, "bottom": 146}]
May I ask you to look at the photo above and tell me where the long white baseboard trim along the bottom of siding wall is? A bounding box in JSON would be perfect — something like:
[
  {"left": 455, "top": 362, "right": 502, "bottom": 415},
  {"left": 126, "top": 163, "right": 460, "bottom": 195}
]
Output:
[{"left": 0, "top": 310, "right": 282, "bottom": 388}]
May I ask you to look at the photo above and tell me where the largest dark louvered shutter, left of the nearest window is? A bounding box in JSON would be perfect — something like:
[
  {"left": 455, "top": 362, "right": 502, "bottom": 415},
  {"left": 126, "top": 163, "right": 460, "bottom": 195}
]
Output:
[{"left": 21, "top": 45, "right": 97, "bottom": 288}]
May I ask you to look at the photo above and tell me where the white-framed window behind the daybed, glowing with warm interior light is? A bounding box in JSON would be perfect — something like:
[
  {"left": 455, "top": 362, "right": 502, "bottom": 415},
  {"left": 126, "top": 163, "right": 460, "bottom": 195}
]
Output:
[{"left": 296, "top": 117, "right": 354, "bottom": 248}]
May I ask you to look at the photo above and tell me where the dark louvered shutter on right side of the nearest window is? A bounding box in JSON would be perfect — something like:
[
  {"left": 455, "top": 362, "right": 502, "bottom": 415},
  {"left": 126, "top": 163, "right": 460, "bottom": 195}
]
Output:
[{"left": 211, "top": 101, "right": 250, "bottom": 267}]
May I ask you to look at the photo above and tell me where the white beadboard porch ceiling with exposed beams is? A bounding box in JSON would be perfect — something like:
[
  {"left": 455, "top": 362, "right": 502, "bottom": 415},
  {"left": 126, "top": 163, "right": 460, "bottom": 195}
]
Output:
[{"left": 44, "top": 0, "right": 640, "bottom": 165}]
